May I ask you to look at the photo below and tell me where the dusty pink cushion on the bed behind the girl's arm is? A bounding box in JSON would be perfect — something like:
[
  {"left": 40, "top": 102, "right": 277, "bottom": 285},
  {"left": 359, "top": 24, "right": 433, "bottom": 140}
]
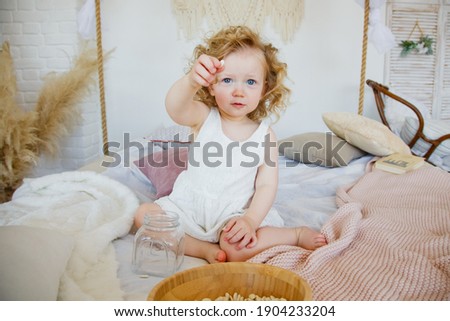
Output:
[{"left": 134, "top": 147, "right": 189, "bottom": 198}]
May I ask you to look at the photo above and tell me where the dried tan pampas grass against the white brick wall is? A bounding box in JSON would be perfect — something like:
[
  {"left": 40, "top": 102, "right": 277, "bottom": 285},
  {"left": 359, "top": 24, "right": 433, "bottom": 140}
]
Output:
[{"left": 0, "top": 42, "right": 97, "bottom": 203}]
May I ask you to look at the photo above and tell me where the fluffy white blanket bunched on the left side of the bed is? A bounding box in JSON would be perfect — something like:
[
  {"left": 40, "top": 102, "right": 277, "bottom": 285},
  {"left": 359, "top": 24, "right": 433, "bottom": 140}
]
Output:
[{"left": 0, "top": 171, "right": 138, "bottom": 300}]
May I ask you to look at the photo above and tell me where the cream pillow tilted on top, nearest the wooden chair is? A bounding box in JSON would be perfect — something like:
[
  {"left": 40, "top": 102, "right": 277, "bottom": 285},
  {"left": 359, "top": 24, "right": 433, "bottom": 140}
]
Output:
[{"left": 322, "top": 112, "right": 411, "bottom": 156}]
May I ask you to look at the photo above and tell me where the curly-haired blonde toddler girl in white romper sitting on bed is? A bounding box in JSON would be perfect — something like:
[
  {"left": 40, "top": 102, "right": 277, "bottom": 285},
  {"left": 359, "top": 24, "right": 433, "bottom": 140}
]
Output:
[{"left": 135, "top": 26, "right": 326, "bottom": 263}]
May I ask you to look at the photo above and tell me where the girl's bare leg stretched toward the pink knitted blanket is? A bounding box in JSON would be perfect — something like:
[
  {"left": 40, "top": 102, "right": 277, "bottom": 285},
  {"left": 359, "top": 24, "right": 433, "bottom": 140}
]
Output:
[{"left": 220, "top": 226, "right": 327, "bottom": 262}]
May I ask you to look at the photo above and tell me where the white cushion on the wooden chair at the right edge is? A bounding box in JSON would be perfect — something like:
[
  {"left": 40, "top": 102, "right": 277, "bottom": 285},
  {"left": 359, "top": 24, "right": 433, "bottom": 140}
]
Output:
[{"left": 400, "top": 117, "right": 450, "bottom": 158}]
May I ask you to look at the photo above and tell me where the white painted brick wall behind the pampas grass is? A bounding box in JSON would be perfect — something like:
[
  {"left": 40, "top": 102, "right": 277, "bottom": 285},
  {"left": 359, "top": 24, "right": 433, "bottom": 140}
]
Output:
[{"left": 0, "top": 0, "right": 102, "bottom": 176}]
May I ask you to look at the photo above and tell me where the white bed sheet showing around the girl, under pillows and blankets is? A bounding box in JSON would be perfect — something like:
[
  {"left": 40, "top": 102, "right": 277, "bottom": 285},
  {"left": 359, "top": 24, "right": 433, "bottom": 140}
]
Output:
[{"left": 104, "top": 155, "right": 373, "bottom": 300}]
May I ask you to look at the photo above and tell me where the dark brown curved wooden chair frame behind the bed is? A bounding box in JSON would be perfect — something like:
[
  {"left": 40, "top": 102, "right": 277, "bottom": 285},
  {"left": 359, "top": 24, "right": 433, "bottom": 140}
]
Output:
[{"left": 366, "top": 79, "right": 450, "bottom": 160}]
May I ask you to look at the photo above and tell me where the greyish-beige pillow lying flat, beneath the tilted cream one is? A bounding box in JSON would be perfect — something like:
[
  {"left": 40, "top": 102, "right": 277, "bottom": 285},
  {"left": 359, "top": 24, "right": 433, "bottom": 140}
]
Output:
[{"left": 278, "top": 132, "right": 365, "bottom": 167}]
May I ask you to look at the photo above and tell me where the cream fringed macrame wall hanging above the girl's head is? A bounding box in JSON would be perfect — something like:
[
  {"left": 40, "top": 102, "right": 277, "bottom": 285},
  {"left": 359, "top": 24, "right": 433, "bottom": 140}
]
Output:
[{"left": 172, "top": 0, "right": 304, "bottom": 43}]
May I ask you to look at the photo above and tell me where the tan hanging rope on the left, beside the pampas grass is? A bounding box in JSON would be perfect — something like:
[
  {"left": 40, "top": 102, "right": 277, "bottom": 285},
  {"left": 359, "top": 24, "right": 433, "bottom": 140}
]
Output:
[{"left": 95, "top": 0, "right": 108, "bottom": 155}]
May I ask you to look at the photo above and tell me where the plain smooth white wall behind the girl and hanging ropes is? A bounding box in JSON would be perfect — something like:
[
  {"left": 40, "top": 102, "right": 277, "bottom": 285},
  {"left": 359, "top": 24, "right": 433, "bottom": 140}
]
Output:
[{"left": 102, "top": 0, "right": 384, "bottom": 142}]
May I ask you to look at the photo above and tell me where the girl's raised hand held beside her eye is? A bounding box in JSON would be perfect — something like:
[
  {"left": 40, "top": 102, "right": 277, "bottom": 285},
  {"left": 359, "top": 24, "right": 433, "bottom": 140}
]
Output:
[{"left": 190, "top": 54, "right": 223, "bottom": 87}]
